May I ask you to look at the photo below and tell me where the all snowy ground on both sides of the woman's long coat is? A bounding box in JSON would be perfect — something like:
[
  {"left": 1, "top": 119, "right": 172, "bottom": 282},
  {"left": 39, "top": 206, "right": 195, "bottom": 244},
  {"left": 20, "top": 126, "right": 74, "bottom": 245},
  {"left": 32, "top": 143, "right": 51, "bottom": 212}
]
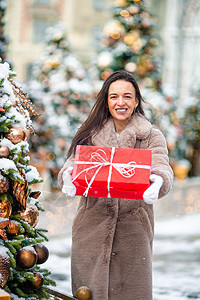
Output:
[{"left": 41, "top": 214, "right": 200, "bottom": 300}]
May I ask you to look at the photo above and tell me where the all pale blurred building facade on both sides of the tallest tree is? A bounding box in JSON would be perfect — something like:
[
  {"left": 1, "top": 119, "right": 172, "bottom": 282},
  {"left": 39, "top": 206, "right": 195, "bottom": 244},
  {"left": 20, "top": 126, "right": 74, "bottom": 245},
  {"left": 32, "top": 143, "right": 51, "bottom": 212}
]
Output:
[{"left": 5, "top": 0, "right": 200, "bottom": 102}]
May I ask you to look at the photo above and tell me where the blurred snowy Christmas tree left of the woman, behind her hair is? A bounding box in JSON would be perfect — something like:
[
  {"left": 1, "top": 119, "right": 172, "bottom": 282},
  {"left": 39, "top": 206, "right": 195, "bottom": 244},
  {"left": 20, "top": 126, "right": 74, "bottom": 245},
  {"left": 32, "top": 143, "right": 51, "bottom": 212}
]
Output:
[{"left": 27, "top": 23, "right": 92, "bottom": 189}]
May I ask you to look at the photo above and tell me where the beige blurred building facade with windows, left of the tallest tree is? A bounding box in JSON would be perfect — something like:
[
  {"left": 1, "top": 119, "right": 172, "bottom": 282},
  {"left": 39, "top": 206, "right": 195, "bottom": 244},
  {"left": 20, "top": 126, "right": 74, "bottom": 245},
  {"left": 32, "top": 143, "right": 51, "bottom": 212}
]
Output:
[{"left": 5, "top": 0, "right": 111, "bottom": 81}]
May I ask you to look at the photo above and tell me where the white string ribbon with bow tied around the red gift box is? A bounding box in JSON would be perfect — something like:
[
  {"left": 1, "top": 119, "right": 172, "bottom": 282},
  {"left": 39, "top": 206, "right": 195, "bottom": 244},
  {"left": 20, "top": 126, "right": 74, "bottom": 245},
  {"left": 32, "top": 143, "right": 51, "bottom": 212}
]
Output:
[{"left": 72, "top": 147, "right": 151, "bottom": 198}]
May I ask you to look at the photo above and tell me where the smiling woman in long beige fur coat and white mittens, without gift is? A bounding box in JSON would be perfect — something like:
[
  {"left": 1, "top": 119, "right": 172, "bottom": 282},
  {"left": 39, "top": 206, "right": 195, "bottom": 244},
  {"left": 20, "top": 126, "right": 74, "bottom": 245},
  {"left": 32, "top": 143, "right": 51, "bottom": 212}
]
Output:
[{"left": 59, "top": 71, "right": 173, "bottom": 300}]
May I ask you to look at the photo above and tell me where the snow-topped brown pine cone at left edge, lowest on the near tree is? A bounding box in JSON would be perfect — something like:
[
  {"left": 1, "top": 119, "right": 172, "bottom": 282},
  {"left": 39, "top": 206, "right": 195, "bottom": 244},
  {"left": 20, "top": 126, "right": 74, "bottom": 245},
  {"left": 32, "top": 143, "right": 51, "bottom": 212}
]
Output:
[{"left": 0, "top": 246, "right": 10, "bottom": 288}]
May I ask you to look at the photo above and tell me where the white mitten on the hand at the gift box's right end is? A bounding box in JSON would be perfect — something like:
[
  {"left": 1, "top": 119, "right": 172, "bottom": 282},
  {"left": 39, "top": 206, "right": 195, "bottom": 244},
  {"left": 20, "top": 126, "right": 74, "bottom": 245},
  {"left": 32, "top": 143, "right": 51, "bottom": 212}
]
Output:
[{"left": 143, "top": 174, "right": 163, "bottom": 204}]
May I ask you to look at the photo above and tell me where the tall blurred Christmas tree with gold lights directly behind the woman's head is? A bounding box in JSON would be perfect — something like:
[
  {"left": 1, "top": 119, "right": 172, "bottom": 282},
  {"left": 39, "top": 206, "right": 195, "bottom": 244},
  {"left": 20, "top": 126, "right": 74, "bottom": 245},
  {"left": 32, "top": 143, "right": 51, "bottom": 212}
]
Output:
[{"left": 94, "top": 0, "right": 180, "bottom": 164}]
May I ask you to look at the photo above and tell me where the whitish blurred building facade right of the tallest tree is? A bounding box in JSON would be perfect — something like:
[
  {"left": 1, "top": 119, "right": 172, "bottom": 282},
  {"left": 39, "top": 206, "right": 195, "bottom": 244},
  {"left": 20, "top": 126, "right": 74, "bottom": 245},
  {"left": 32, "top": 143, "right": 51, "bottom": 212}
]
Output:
[{"left": 152, "top": 0, "right": 200, "bottom": 105}]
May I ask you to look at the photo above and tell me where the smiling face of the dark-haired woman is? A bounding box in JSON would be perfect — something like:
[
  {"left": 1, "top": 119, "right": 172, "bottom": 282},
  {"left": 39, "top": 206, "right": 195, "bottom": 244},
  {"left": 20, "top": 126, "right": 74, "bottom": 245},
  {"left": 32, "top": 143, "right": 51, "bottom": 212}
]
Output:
[{"left": 108, "top": 80, "right": 138, "bottom": 125}]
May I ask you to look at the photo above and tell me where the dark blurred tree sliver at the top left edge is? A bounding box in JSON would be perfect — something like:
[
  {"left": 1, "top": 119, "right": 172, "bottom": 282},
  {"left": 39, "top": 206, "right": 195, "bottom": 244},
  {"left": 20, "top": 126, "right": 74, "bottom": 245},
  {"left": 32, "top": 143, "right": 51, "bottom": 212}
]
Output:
[{"left": 0, "top": 0, "right": 8, "bottom": 61}]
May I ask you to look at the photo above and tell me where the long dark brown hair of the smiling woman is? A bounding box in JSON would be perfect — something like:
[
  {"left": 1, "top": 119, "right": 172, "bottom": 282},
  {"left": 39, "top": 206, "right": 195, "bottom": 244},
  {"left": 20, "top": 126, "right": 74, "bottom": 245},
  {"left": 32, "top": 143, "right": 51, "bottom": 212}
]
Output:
[{"left": 68, "top": 70, "right": 145, "bottom": 157}]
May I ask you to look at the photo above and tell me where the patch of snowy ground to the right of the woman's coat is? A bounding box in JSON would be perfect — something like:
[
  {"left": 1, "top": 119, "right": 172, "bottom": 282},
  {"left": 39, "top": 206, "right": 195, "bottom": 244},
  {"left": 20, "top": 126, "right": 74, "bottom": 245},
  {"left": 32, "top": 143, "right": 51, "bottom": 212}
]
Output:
[{"left": 153, "top": 214, "right": 200, "bottom": 300}]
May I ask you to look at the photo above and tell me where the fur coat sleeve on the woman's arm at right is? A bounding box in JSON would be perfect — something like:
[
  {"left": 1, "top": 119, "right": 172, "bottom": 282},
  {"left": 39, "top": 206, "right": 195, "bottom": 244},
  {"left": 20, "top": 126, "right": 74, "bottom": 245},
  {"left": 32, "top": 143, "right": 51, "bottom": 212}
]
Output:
[{"left": 148, "top": 129, "right": 174, "bottom": 198}]
